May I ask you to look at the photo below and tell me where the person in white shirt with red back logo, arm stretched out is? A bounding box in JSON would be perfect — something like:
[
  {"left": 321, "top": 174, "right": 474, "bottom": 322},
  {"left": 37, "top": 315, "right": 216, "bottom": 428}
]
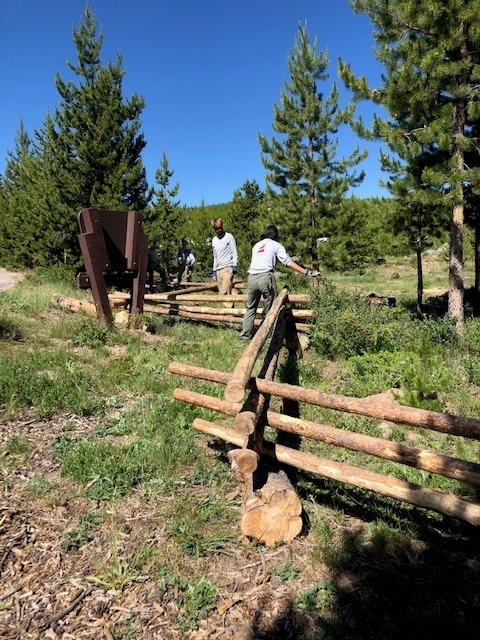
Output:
[{"left": 240, "top": 225, "right": 321, "bottom": 340}]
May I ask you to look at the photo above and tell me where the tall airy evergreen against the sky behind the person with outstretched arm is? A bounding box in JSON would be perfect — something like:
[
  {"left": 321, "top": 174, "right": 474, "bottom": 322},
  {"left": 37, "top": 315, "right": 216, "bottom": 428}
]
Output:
[{"left": 258, "top": 24, "right": 366, "bottom": 261}]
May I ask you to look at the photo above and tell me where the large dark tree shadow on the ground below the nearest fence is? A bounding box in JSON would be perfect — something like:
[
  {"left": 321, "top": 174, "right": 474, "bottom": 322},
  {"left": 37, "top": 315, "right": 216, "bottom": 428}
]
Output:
[{"left": 244, "top": 484, "right": 480, "bottom": 640}]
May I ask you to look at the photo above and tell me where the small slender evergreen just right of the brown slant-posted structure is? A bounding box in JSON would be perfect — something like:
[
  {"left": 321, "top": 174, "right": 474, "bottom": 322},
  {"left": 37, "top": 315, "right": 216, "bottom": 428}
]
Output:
[{"left": 144, "top": 151, "right": 182, "bottom": 275}]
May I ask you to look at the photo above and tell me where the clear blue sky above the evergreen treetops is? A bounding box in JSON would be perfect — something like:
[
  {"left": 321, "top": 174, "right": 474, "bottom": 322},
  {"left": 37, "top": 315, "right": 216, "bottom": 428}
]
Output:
[{"left": 0, "top": 0, "right": 388, "bottom": 205}]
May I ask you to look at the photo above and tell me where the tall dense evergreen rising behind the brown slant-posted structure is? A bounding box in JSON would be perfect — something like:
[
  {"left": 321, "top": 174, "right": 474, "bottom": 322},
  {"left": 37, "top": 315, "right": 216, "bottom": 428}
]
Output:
[{"left": 1, "top": 5, "right": 149, "bottom": 266}]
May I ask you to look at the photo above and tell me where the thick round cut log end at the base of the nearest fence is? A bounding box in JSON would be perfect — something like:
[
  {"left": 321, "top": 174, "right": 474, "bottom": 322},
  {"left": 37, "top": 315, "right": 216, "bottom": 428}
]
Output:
[{"left": 241, "top": 471, "right": 303, "bottom": 547}]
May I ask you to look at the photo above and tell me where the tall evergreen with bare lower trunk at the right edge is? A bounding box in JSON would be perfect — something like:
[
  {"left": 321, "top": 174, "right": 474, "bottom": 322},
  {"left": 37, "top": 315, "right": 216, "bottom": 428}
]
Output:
[{"left": 340, "top": 0, "right": 480, "bottom": 328}]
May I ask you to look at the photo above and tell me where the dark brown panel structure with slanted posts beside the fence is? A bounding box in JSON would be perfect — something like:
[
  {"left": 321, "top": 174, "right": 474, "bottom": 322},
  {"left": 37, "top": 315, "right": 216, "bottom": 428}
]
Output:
[{"left": 77, "top": 209, "right": 148, "bottom": 325}]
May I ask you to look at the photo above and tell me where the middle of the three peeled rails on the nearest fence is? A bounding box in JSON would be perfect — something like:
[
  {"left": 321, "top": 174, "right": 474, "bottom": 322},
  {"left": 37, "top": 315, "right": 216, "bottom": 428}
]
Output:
[{"left": 173, "top": 388, "right": 480, "bottom": 486}]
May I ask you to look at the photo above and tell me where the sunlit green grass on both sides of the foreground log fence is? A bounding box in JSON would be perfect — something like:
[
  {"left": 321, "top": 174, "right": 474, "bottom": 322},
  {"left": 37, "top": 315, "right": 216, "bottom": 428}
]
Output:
[{"left": 0, "top": 258, "right": 480, "bottom": 638}]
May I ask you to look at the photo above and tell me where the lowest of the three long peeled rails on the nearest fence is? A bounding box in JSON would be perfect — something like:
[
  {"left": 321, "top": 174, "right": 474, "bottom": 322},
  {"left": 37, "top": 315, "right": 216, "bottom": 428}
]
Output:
[{"left": 193, "top": 418, "right": 480, "bottom": 526}]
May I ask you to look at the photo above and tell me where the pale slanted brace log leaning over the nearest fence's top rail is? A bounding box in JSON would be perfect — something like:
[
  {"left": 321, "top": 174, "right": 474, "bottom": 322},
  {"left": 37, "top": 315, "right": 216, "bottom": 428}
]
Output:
[{"left": 224, "top": 288, "right": 288, "bottom": 402}]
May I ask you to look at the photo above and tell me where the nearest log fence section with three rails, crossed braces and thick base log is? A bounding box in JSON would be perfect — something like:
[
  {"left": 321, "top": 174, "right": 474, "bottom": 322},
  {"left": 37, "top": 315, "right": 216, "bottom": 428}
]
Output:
[{"left": 169, "top": 289, "right": 480, "bottom": 545}]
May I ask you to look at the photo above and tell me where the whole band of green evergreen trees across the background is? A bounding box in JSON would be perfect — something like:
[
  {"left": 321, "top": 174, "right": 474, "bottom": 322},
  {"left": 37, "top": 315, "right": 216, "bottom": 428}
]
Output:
[{"left": 0, "top": 0, "right": 480, "bottom": 328}]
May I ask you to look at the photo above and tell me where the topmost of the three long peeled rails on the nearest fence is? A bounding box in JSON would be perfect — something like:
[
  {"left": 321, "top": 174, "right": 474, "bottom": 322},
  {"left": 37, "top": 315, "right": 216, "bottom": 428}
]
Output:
[{"left": 168, "top": 362, "right": 480, "bottom": 440}]
